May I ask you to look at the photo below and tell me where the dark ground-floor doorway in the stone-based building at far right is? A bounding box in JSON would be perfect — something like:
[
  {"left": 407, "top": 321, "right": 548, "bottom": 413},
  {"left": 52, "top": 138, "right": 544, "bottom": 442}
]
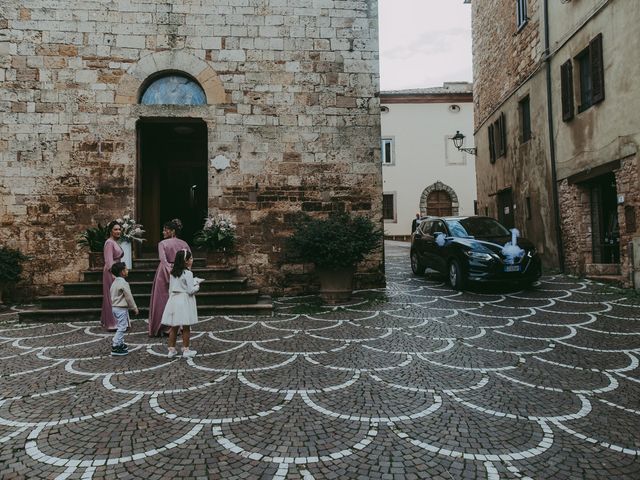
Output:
[{"left": 590, "top": 172, "right": 620, "bottom": 263}]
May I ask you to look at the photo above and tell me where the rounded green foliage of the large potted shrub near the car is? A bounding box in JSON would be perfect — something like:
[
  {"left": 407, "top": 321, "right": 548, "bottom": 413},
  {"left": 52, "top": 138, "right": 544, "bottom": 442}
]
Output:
[{"left": 286, "top": 213, "right": 382, "bottom": 268}]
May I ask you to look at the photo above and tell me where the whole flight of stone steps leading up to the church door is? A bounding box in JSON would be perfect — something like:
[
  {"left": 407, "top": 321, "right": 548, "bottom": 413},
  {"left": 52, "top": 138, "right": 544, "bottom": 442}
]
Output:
[{"left": 19, "top": 258, "right": 273, "bottom": 322}]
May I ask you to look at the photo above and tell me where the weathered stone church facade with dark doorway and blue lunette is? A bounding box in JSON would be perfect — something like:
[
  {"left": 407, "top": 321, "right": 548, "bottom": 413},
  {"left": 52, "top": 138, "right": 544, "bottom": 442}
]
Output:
[{"left": 0, "top": 0, "right": 384, "bottom": 300}]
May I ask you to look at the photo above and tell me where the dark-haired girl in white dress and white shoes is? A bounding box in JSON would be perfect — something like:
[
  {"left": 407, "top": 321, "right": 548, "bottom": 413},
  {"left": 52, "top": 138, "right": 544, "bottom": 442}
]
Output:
[{"left": 162, "top": 250, "right": 202, "bottom": 358}]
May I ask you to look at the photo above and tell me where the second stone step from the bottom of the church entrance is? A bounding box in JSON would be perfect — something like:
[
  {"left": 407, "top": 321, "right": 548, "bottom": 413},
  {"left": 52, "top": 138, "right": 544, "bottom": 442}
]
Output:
[{"left": 38, "top": 290, "right": 260, "bottom": 310}]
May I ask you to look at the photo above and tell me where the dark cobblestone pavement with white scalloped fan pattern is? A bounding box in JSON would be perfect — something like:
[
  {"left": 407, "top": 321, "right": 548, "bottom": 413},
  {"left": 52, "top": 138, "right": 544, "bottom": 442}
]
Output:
[{"left": 0, "top": 246, "right": 640, "bottom": 480}]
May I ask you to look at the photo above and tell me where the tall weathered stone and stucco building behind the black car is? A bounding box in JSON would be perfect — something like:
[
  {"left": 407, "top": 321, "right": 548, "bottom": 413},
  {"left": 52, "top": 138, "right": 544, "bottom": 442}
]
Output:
[{"left": 472, "top": 0, "right": 640, "bottom": 286}]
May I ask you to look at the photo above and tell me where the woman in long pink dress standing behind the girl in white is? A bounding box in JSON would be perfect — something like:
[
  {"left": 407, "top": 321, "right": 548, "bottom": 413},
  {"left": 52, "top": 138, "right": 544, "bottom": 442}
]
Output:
[{"left": 149, "top": 218, "right": 191, "bottom": 337}]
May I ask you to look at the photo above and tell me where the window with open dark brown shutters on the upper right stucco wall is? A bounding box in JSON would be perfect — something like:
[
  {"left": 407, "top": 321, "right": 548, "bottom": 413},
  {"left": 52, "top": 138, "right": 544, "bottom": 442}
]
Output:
[{"left": 560, "top": 34, "right": 604, "bottom": 122}]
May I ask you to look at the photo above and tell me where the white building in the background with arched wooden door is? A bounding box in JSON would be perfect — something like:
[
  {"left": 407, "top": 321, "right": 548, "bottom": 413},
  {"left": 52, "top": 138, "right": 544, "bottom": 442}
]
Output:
[{"left": 380, "top": 82, "right": 476, "bottom": 239}]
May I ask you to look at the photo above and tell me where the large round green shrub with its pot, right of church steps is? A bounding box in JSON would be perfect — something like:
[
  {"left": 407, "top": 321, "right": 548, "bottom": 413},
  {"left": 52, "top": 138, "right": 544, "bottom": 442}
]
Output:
[{"left": 286, "top": 213, "right": 382, "bottom": 304}]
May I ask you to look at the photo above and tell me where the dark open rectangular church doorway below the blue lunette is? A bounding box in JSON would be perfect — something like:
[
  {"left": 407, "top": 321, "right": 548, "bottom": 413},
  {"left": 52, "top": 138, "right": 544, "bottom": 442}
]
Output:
[{"left": 137, "top": 118, "right": 208, "bottom": 253}]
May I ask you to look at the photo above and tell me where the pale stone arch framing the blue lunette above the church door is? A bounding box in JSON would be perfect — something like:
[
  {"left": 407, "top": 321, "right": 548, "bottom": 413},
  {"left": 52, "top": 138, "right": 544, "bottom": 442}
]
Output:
[{"left": 115, "top": 51, "right": 228, "bottom": 105}]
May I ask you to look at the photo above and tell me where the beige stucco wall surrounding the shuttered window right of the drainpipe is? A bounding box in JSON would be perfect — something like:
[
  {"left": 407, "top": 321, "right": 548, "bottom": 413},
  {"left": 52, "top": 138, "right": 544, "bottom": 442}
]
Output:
[{"left": 550, "top": 0, "right": 640, "bottom": 180}]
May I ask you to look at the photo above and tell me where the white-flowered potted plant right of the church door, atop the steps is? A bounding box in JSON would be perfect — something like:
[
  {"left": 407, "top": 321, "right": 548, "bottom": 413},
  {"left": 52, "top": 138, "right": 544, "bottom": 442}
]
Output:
[{"left": 193, "top": 214, "right": 236, "bottom": 265}]
